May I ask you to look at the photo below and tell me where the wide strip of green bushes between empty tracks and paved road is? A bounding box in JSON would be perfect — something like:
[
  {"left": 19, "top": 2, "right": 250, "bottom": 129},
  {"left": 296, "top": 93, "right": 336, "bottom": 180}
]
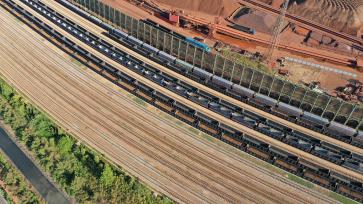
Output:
[{"left": 0, "top": 77, "right": 172, "bottom": 203}]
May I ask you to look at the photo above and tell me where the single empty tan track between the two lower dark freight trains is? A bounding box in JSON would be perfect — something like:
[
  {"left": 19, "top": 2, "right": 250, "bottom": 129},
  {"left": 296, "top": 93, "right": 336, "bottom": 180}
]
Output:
[{"left": 10, "top": 0, "right": 363, "bottom": 181}]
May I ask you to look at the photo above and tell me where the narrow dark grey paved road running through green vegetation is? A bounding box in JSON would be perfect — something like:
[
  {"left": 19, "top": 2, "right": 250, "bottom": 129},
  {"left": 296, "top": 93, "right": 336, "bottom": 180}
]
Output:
[{"left": 0, "top": 128, "right": 71, "bottom": 204}]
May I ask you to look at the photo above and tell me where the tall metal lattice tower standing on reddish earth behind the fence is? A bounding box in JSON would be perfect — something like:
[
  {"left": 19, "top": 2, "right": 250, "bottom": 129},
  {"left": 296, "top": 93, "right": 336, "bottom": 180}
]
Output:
[{"left": 266, "top": 0, "right": 290, "bottom": 63}]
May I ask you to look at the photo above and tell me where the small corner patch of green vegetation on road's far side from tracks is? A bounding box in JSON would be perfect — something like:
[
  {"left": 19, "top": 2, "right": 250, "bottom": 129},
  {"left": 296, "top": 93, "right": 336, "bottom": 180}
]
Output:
[{"left": 0, "top": 154, "right": 42, "bottom": 204}]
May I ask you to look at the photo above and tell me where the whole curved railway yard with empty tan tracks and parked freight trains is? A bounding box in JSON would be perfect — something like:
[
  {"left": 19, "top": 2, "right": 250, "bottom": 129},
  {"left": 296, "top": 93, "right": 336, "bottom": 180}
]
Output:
[{"left": 0, "top": 0, "right": 363, "bottom": 203}]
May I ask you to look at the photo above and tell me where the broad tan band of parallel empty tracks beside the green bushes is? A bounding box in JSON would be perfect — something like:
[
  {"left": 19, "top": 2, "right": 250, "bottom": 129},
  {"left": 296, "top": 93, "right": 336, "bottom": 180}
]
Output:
[{"left": 0, "top": 1, "right": 342, "bottom": 203}]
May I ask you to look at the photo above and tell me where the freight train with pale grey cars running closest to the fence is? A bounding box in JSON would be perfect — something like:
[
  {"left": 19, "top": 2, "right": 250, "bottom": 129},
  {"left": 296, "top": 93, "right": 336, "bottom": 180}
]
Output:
[{"left": 50, "top": 0, "right": 363, "bottom": 145}]
